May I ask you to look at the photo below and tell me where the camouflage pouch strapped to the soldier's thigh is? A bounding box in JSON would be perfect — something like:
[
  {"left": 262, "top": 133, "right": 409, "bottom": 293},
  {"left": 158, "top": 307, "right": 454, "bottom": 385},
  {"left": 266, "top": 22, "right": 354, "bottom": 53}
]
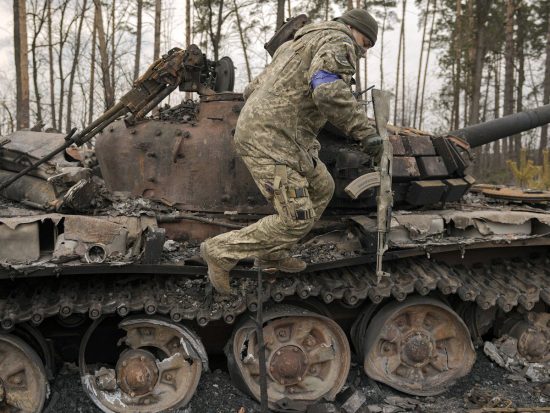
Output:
[{"left": 266, "top": 165, "right": 315, "bottom": 220}]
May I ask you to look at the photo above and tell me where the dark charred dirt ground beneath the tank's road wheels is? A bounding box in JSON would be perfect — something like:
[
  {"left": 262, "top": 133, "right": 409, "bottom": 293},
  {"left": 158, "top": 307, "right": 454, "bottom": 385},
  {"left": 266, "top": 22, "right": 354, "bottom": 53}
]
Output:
[{"left": 45, "top": 350, "right": 550, "bottom": 413}]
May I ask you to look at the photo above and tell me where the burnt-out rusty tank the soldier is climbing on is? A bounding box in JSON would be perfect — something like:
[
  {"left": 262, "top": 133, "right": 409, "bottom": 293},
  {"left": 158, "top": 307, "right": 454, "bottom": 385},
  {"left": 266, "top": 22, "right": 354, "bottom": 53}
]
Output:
[{"left": 0, "top": 41, "right": 550, "bottom": 412}]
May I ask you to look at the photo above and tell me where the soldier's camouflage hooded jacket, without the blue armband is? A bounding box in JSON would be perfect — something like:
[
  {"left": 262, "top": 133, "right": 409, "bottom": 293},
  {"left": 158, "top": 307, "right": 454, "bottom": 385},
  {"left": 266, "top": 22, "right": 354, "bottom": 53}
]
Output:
[{"left": 235, "top": 21, "right": 375, "bottom": 175}]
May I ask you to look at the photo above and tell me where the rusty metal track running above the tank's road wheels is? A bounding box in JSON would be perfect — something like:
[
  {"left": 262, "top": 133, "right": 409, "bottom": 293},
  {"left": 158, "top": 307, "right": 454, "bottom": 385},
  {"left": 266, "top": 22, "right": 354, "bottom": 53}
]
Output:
[{"left": 0, "top": 257, "right": 550, "bottom": 330}]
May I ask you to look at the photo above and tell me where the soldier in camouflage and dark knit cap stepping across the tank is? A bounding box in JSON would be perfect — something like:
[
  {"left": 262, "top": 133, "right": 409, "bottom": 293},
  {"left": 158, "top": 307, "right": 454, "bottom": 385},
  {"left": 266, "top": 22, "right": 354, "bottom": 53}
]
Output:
[{"left": 201, "top": 9, "right": 382, "bottom": 294}]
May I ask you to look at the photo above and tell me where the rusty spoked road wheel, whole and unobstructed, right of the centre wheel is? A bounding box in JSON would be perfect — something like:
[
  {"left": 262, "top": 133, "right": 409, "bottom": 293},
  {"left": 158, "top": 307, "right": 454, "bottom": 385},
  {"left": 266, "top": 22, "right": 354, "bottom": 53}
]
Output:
[{"left": 362, "top": 297, "right": 475, "bottom": 396}]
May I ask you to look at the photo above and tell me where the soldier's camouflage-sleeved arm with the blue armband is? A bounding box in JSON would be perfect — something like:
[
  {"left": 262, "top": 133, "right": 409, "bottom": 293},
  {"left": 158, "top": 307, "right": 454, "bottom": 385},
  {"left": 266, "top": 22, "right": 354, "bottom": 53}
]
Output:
[{"left": 308, "top": 36, "right": 376, "bottom": 141}]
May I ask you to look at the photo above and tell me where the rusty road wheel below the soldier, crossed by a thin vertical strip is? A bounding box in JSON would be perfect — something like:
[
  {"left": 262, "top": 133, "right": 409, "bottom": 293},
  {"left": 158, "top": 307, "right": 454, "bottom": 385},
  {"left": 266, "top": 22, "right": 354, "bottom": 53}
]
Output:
[{"left": 226, "top": 306, "right": 350, "bottom": 411}]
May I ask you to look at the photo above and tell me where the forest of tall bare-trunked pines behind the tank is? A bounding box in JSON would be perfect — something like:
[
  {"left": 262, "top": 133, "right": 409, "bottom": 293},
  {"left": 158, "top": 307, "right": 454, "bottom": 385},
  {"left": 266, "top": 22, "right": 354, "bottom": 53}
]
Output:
[{"left": 0, "top": 0, "right": 550, "bottom": 183}]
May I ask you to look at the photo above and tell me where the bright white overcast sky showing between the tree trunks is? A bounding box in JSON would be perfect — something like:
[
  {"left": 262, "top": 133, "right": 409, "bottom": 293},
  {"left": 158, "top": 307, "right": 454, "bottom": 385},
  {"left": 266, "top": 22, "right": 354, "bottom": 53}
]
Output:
[{"left": 0, "top": 0, "right": 441, "bottom": 128}]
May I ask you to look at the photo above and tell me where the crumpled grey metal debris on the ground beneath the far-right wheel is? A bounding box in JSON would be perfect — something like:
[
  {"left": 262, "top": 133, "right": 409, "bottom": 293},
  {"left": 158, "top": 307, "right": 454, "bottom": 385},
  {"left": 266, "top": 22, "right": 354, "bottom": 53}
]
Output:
[{"left": 483, "top": 335, "right": 550, "bottom": 382}]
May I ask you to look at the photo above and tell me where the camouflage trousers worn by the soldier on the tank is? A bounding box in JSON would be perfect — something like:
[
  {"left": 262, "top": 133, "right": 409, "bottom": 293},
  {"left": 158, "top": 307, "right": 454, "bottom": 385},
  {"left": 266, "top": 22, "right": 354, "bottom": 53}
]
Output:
[{"left": 206, "top": 157, "right": 334, "bottom": 271}]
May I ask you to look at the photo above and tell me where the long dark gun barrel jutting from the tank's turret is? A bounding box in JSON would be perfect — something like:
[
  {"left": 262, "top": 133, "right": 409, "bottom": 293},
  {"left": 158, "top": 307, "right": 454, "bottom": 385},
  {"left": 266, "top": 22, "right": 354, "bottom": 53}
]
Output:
[{"left": 449, "top": 105, "right": 550, "bottom": 148}]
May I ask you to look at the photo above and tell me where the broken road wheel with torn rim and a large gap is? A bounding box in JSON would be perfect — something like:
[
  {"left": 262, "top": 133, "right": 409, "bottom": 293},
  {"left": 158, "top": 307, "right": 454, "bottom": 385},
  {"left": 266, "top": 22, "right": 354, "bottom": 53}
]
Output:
[{"left": 79, "top": 316, "right": 208, "bottom": 413}]
